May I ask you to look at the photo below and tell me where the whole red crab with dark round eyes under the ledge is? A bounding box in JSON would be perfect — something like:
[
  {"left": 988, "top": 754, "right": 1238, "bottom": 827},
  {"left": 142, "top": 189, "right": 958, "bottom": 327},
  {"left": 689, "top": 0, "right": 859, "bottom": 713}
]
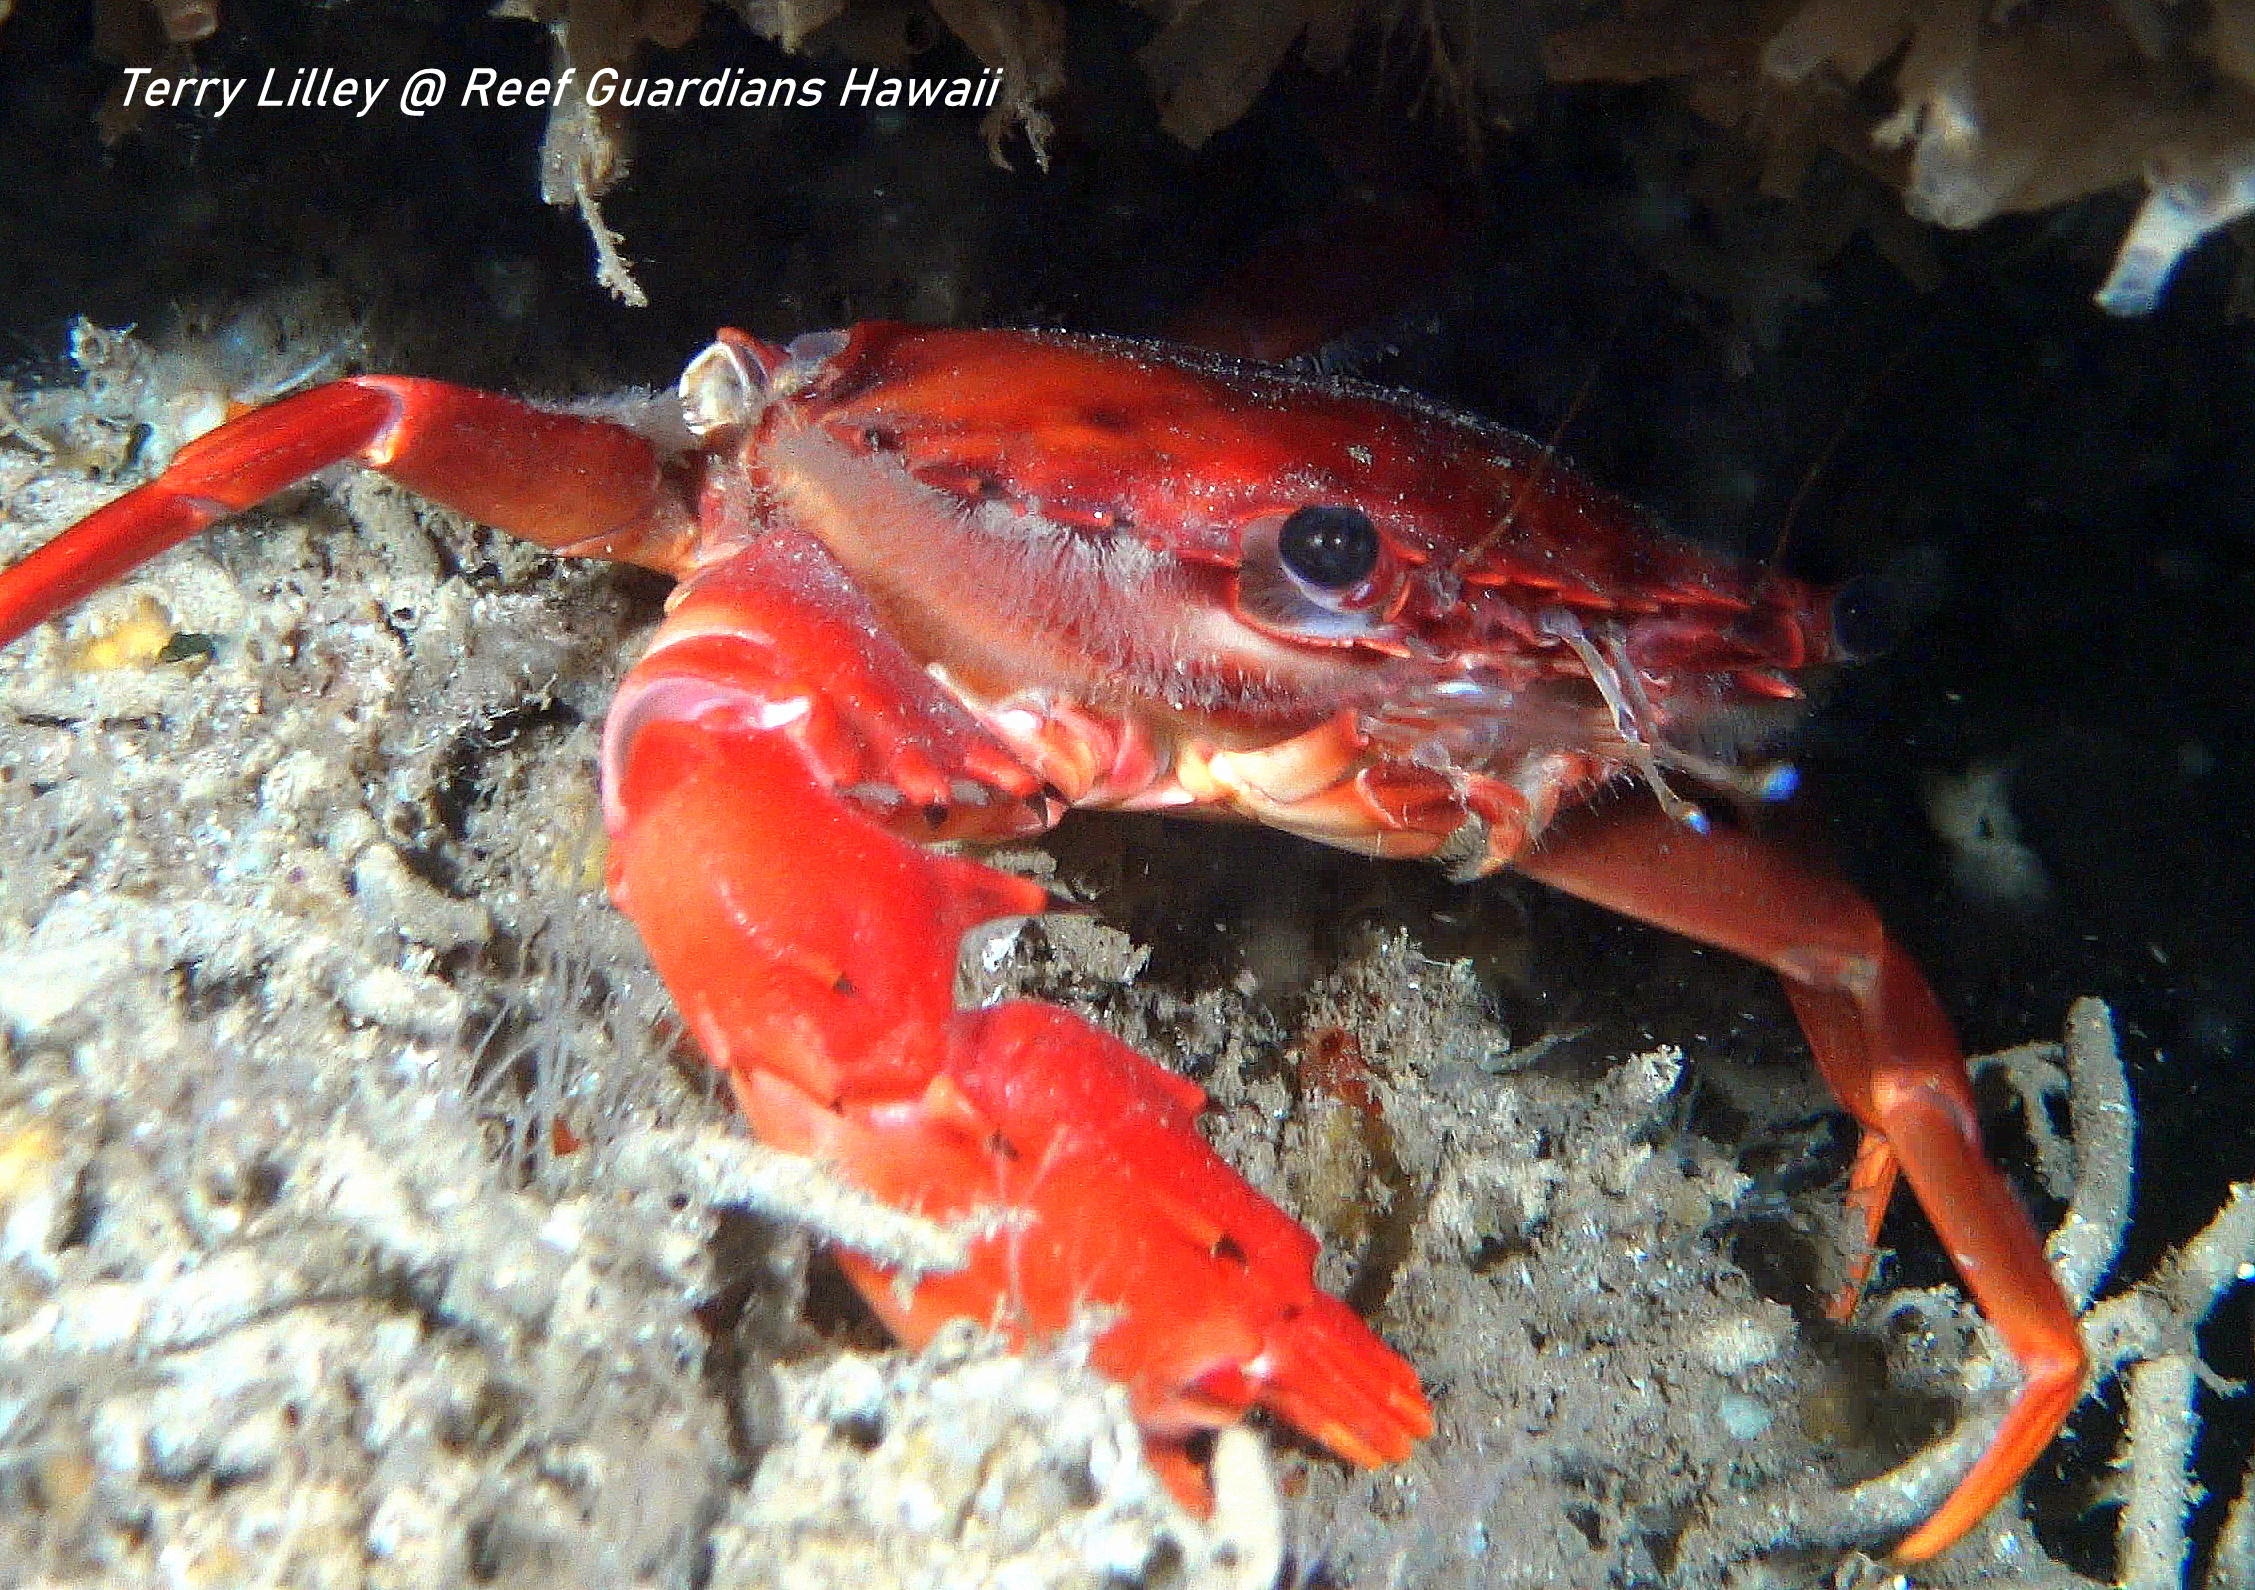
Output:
[{"left": 0, "top": 325, "right": 2084, "bottom": 1558}]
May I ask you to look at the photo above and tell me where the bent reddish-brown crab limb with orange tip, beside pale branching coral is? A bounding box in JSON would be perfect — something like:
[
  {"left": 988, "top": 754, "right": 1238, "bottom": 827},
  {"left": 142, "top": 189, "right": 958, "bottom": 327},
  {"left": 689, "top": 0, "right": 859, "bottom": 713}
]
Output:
[{"left": 1513, "top": 805, "right": 2088, "bottom": 1561}]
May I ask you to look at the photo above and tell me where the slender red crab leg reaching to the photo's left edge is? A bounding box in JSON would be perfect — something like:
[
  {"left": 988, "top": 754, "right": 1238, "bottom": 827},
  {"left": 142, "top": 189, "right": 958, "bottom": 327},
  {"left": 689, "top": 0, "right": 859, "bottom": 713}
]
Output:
[{"left": 0, "top": 377, "right": 665, "bottom": 645}]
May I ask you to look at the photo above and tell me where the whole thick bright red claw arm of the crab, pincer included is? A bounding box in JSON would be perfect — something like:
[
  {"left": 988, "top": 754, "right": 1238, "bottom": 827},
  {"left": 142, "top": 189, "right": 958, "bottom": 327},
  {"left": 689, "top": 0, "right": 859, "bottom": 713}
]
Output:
[{"left": 604, "top": 530, "right": 1432, "bottom": 1500}]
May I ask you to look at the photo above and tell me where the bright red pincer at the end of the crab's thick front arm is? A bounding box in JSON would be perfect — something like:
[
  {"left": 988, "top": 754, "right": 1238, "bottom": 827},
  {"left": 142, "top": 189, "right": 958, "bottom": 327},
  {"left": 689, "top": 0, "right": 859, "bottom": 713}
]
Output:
[{"left": 733, "top": 1004, "right": 1432, "bottom": 1507}]
